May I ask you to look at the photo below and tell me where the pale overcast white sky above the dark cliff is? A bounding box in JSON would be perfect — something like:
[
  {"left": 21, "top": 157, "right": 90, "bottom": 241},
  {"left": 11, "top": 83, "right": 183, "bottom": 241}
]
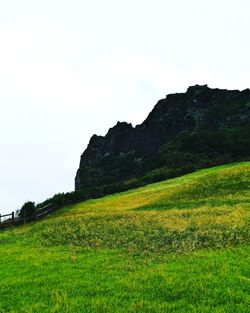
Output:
[{"left": 0, "top": 0, "right": 250, "bottom": 214}]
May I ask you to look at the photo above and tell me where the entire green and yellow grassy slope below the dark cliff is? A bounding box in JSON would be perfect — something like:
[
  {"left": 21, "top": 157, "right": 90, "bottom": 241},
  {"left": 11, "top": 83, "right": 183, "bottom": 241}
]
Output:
[{"left": 0, "top": 162, "right": 250, "bottom": 313}]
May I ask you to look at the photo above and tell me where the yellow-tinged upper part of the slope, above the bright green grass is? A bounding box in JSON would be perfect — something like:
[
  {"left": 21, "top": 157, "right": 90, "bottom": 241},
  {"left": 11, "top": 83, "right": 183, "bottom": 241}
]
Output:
[{"left": 23, "top": 163, "right": 250, "bottom": 253}]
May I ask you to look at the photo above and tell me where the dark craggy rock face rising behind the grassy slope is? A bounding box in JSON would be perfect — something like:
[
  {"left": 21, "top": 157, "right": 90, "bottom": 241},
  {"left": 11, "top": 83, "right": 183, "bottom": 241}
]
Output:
[{"left": 75, "top": 85, "right": 250, "bottom": 190}]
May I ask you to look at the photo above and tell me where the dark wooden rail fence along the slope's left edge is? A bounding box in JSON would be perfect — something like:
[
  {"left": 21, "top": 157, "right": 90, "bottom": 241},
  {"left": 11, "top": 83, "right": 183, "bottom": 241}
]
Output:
[{"left": 0, "top": 204, "right": 57, "bottom": 228}]
